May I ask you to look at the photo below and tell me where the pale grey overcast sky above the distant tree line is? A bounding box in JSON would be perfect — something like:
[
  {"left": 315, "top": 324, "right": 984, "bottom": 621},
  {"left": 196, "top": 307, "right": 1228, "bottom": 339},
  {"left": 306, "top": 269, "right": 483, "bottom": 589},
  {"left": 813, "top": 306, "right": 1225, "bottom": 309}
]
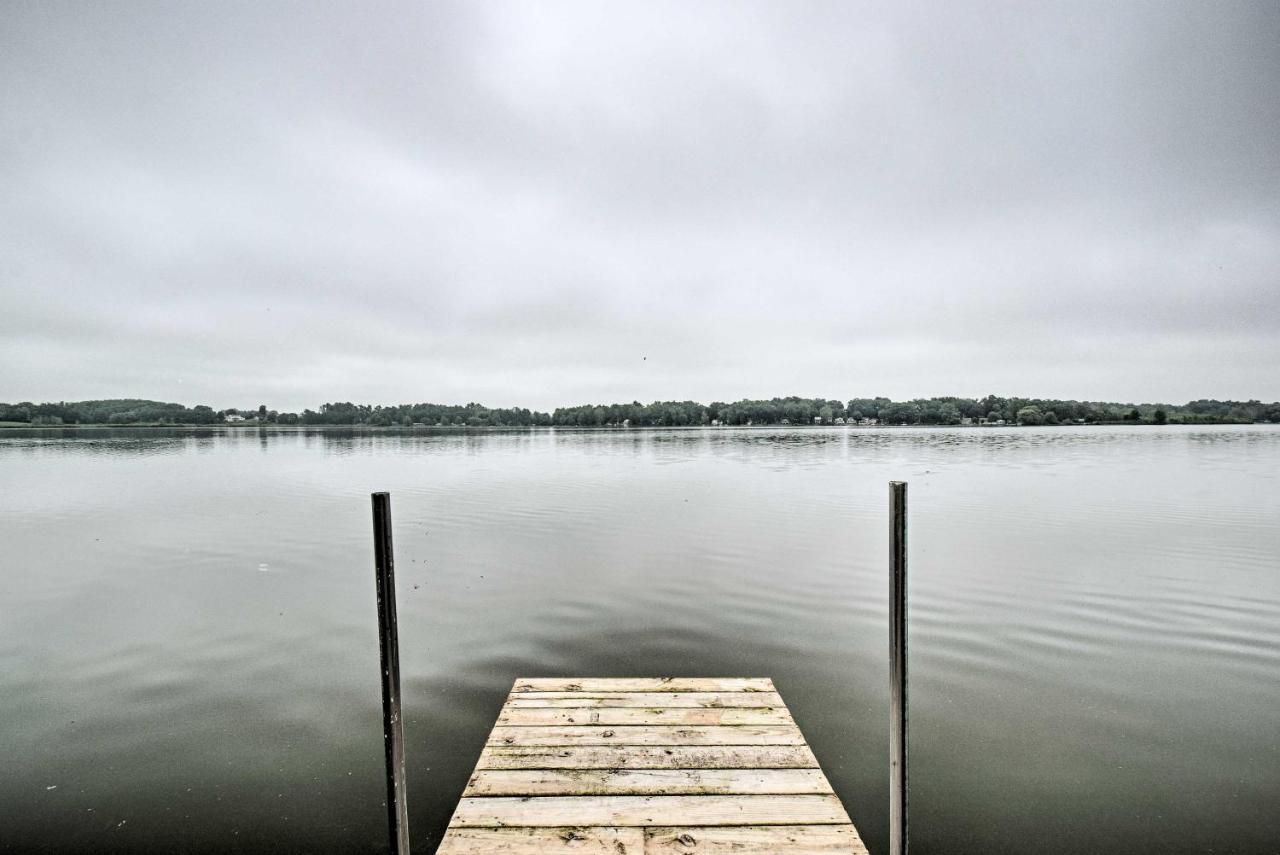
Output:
[{"left": 0, "top": 0, "right": 1280, "bottom": 410}]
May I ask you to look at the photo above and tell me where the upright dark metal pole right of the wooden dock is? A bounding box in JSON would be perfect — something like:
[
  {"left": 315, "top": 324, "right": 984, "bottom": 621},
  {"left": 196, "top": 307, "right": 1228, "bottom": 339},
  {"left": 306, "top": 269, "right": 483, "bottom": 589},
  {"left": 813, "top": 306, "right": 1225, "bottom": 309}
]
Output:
[{"left": 888, "top": 481, "right": 906, "bottom": 855}]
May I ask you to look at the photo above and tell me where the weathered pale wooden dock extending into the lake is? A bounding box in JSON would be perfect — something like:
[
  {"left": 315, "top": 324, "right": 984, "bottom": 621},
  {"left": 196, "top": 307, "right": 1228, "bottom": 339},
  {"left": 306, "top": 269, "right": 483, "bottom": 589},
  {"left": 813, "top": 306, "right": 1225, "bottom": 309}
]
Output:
[{"left": 439, "top": 677, "right": 867, "bottom": 855}]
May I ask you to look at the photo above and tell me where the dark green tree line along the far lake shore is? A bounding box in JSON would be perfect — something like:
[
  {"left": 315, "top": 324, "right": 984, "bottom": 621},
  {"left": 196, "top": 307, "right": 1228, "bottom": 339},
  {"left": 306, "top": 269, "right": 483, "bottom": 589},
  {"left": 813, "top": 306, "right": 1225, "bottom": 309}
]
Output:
[{"left": 0, "top": 396, "right": 1280, "bottom": 428}]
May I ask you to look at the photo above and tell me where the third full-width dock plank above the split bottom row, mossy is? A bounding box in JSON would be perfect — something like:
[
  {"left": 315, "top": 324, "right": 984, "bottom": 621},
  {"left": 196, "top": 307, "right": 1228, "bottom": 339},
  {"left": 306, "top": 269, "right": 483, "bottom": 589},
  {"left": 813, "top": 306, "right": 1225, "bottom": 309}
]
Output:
[{"left": 476, "top": 745, "right": 818, "bottom": 769}]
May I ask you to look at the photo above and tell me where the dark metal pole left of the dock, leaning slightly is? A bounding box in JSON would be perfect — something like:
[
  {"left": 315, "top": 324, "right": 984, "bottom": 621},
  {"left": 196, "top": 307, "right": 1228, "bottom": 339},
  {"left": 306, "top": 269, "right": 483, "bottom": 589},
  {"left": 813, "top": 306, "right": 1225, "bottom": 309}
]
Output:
[{"left": 372, "top": 493, "right": 410, "bottom": 855}]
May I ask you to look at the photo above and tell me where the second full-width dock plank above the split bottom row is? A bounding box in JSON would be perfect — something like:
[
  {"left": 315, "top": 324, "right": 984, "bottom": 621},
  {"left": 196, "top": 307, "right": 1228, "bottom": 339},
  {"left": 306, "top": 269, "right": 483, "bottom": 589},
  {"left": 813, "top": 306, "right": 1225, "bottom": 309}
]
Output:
[{"left": 462, "top": 769, "right": 831, "bottom": 796}]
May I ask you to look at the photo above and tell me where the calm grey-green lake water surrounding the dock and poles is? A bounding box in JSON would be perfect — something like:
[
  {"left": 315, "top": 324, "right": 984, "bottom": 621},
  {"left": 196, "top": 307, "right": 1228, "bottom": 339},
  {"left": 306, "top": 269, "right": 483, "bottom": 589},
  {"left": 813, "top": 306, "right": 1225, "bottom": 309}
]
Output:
[{"left": 0, "top": 425, "right": 1280, "bottom": 855}]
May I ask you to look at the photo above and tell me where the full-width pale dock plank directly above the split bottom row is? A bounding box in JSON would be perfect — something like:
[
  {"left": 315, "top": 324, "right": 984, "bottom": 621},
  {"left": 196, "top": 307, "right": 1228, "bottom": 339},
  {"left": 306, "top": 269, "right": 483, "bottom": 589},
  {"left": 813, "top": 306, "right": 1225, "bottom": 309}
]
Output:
[{"left": 451, "top": 795, "right": 849, "bottom": 827}]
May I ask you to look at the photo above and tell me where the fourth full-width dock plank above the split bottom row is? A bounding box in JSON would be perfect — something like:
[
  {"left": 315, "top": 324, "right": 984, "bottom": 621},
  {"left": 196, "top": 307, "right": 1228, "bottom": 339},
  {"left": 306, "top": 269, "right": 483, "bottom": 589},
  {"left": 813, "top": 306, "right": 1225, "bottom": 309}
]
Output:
[{"left": 489, "top": 724, "right": 804, "bottom": 745}]
